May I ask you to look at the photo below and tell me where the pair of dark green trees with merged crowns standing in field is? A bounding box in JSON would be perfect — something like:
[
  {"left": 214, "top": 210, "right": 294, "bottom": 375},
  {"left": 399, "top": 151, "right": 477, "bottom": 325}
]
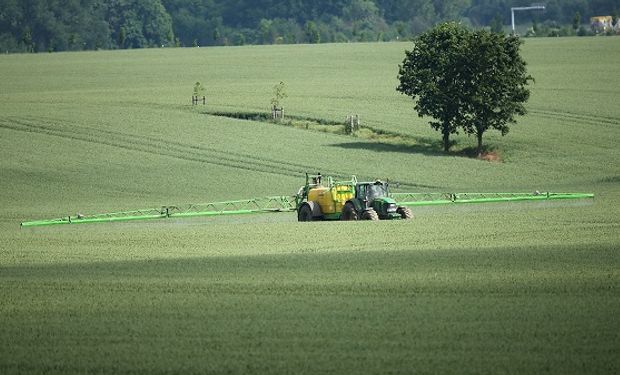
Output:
[{"left": 397, "top": 22, "right": 532, "bottom": 154}]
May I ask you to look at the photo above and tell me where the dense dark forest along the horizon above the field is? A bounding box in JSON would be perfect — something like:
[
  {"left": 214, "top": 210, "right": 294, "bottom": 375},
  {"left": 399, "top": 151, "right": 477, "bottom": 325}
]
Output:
[{"left": 0, "top": 0, "right": 620, "bottom": 52}]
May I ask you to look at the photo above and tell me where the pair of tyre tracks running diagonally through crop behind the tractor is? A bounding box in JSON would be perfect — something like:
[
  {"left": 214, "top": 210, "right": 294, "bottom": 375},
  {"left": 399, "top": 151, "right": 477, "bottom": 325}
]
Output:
[{"left": 0, "top": 117, "right": 436, "bottom": 188}]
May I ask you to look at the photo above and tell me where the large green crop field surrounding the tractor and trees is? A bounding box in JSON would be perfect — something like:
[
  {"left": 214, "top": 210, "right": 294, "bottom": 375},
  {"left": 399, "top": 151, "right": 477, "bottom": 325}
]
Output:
[{"left": 0, "top": 37, "right": 620, "bottom": 374}]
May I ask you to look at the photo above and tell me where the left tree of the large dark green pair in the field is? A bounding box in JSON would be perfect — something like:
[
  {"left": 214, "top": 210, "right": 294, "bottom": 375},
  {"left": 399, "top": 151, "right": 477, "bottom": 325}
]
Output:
[{"left": 396, "top": 22, "right": 469, "bottom": 152}]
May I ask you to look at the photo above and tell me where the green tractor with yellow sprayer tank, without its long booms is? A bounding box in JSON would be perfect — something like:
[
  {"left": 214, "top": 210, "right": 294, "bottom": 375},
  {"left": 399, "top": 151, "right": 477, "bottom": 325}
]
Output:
[{"left": 295, "top": 173, "right": 413, "bottom": 221}]
